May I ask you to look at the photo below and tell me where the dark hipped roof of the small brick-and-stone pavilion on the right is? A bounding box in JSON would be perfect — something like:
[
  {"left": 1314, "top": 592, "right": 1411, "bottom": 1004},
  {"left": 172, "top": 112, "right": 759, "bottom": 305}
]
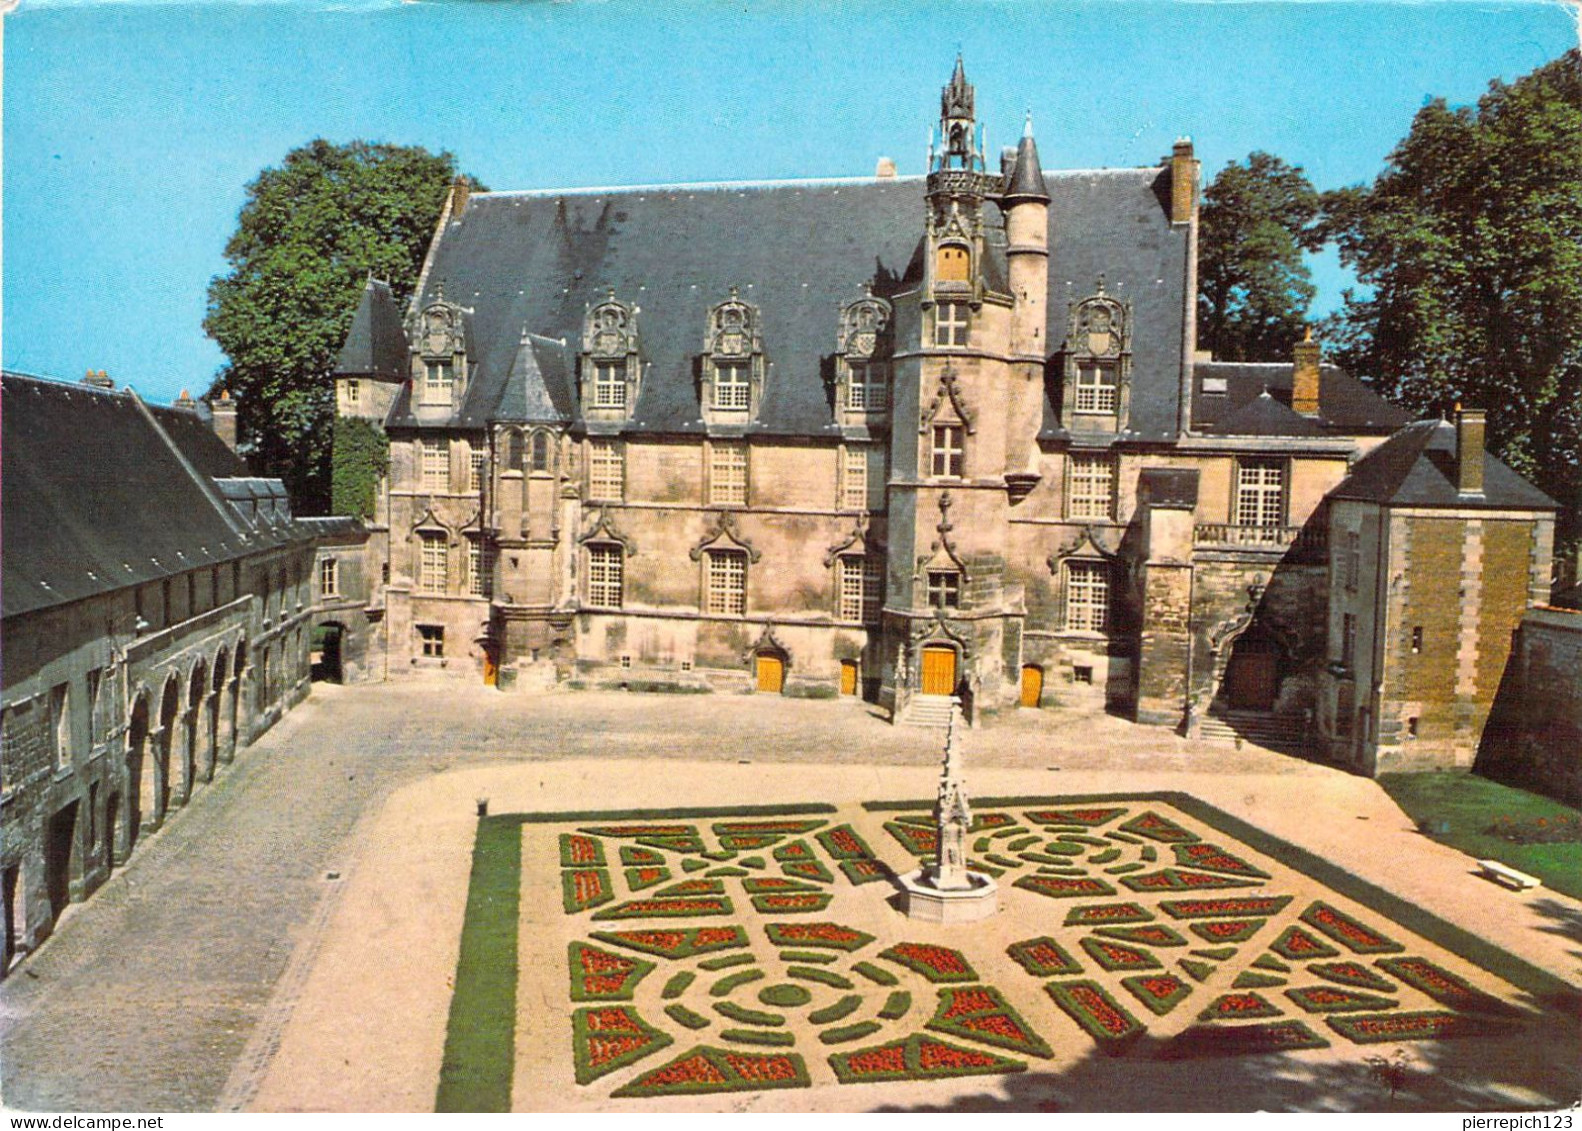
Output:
[{"left": 1329, "top": 421, "right": 1557, "bottom": 511}]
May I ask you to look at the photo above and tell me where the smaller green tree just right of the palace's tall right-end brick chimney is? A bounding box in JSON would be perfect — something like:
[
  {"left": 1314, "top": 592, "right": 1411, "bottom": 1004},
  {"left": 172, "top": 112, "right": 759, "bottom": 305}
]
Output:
[{"left": 1198, "top": 152, "right": 1321, "bottom": 361}]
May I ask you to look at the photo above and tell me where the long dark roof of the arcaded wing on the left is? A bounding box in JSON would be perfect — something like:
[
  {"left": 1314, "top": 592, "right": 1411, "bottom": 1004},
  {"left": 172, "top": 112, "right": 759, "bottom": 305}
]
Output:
[{"left": 0, "top": 373, "right": 322, "bottom": 617}]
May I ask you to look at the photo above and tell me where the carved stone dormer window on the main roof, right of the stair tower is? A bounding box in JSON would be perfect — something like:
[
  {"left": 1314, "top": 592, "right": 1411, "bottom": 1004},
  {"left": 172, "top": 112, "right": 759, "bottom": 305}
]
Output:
[{"left": 1060, "top": 275, "right": 1133, "bottom": 432}]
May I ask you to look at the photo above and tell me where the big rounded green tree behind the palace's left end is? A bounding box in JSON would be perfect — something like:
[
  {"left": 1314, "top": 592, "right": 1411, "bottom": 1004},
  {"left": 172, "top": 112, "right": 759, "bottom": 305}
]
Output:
[{"left": 204, "top": 139, "right": 468, "bottom": 514}]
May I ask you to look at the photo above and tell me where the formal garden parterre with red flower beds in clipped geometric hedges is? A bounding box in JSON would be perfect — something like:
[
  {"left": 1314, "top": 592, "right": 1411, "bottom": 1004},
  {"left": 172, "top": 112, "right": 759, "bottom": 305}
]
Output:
[{"left": 441, "top": 796, "right": 1536, "bottom": 1109}]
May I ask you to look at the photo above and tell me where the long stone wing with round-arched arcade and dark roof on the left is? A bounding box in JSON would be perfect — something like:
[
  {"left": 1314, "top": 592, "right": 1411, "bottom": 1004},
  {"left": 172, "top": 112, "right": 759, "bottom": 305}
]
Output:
[{"left": 0, "top": 375, "right": 335, "bottom": 976}]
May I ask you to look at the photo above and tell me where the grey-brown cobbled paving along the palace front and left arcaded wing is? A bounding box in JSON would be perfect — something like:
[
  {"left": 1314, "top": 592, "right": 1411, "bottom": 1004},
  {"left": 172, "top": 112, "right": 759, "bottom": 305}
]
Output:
[{"left": 0, "top": 682, "right": 1309, "bottom": 1112}]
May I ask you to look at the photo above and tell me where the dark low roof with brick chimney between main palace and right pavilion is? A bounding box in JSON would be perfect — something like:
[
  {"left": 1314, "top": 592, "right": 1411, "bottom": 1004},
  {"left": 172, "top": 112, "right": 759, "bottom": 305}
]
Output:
[{"left": 1191, "top": 361, "right": 1411, "bottom": 437}]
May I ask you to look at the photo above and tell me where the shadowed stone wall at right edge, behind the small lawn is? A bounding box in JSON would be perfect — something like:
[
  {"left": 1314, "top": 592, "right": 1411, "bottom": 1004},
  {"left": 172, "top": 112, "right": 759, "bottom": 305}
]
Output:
[{"left": 1476, "top": 607, "right": 1582, "bottom": 805}]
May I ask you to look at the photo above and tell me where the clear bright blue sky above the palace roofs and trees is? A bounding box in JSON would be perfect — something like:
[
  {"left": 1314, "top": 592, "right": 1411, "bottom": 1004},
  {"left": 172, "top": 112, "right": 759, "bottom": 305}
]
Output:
[{"left": 3, "top": 0, "right": 1577, "bottom": 400}]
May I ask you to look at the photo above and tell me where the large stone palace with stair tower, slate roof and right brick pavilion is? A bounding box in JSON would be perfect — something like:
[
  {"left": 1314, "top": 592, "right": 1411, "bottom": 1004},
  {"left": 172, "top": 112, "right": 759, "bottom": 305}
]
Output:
[{"left": 321, "top": 60, "right": 1554, "bottom": 770}]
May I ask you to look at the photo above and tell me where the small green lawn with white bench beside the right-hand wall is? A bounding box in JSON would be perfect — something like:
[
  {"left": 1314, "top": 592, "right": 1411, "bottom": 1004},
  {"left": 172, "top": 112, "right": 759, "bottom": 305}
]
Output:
[{"left": 1380, "top": 772, "right": 1582, "bottom": 898}]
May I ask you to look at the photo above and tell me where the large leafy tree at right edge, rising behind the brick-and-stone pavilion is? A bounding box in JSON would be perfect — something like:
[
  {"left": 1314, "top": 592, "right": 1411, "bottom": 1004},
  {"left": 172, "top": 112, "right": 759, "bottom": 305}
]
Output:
[{"left": 1324, "top": 51, "right": 1582, "bottom": 539}]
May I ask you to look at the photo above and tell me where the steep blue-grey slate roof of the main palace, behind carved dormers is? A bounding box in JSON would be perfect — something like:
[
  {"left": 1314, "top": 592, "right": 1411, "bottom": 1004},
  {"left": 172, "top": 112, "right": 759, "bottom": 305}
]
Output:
[{"left": 363, "top": 168, "right": 1187, "bottom": 438}]
